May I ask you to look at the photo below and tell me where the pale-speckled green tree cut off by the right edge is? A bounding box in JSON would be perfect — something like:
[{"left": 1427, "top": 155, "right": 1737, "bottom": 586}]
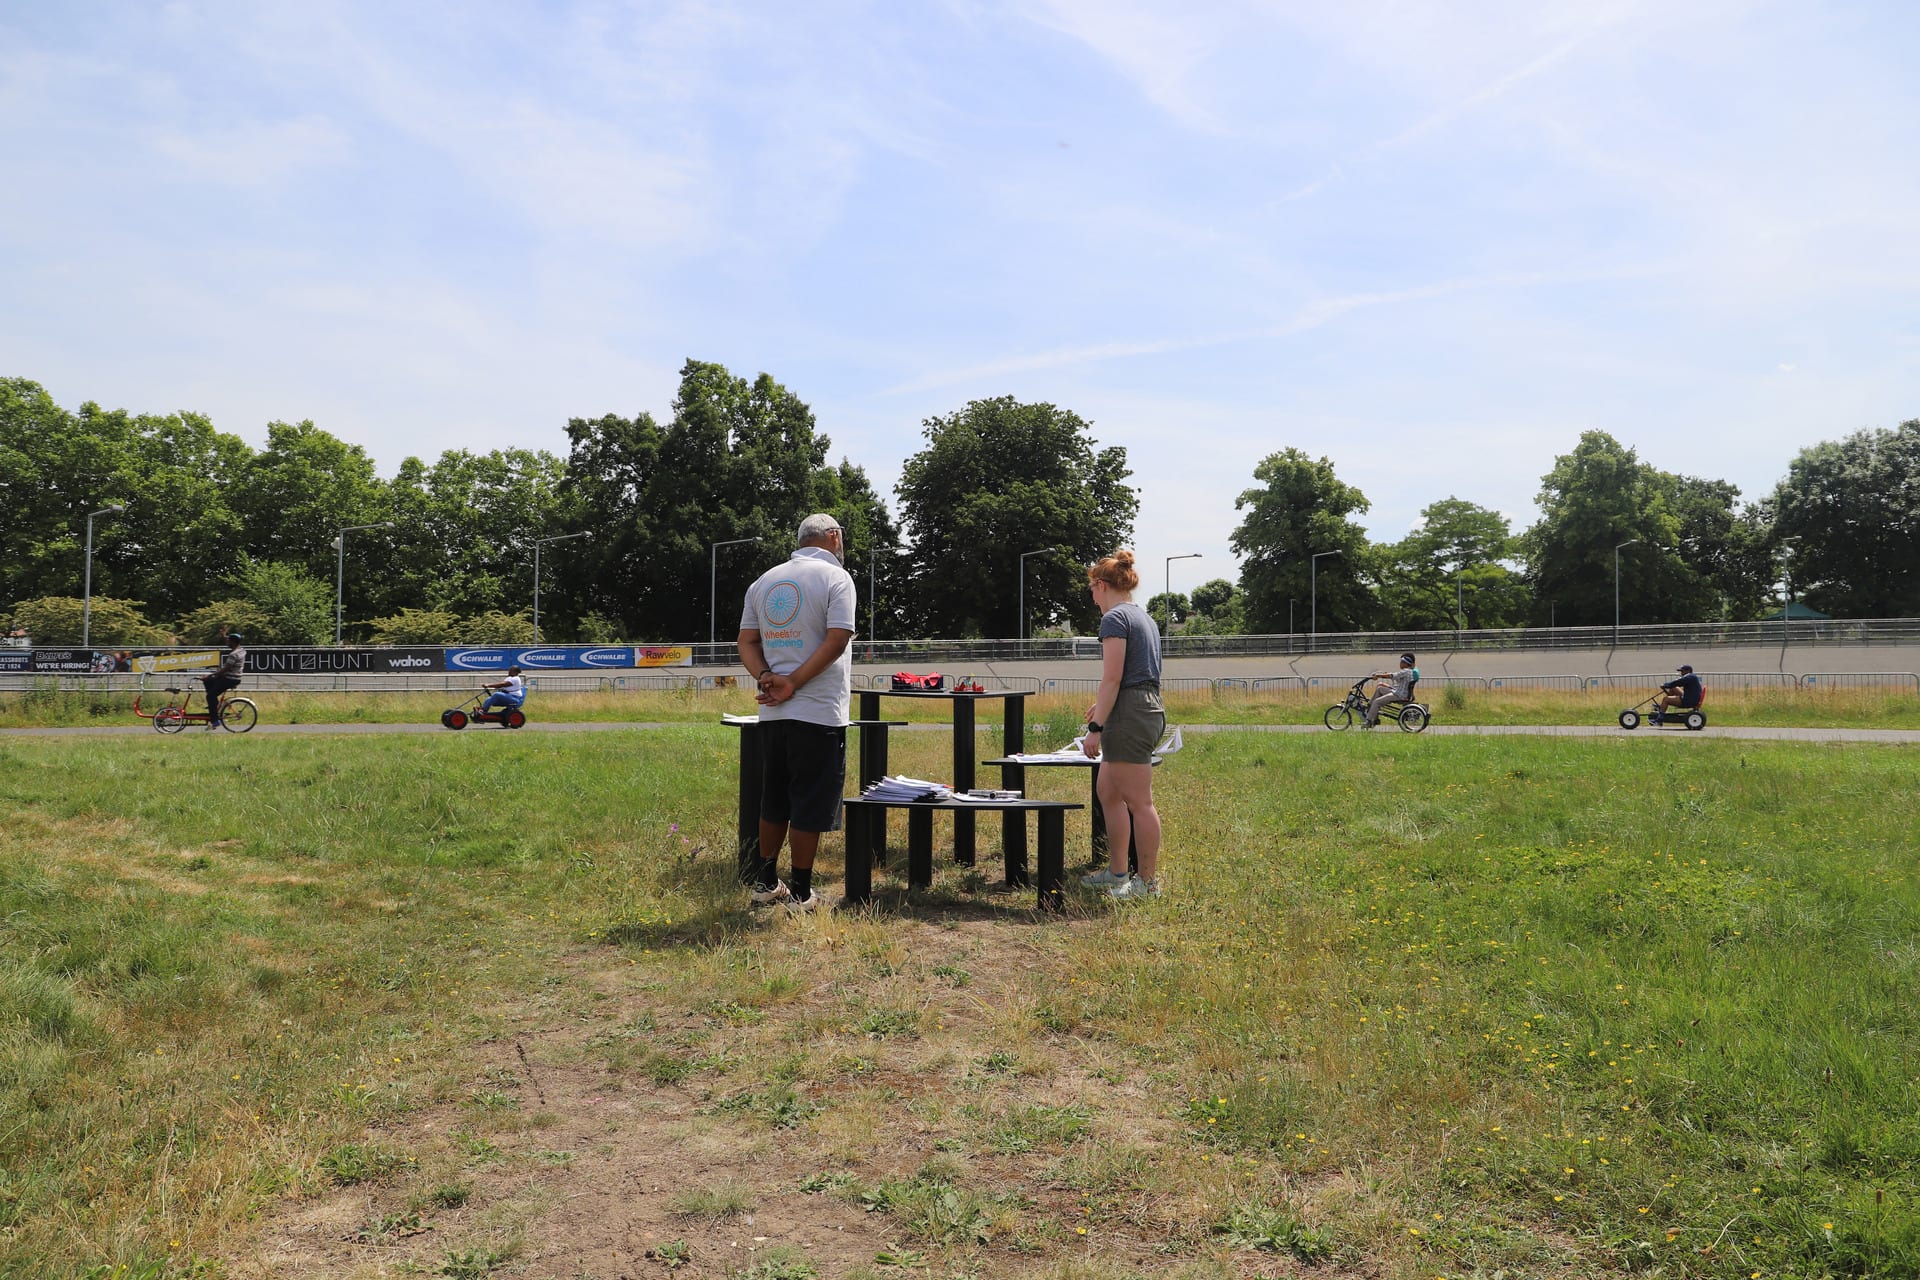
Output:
[{"left": 1772, "top": 418, "right": 1920, "bottom": 618}]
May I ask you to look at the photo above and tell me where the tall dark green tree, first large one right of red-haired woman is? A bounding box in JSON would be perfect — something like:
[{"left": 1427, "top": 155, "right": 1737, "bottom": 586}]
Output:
[{"left": 1233, "top": 449, "right": 1377, "bottom": 635}]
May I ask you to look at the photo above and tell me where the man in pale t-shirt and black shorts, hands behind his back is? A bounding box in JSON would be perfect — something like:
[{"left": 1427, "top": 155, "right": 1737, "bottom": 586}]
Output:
[{"left": 737, "top": 514, "right": 856, "bottom": 912}]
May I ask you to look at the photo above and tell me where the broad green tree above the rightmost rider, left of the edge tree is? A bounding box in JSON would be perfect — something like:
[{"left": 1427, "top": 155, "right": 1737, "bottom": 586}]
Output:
[{"left": 1521, "top": 432, "right": 1749, "bottom": 626}]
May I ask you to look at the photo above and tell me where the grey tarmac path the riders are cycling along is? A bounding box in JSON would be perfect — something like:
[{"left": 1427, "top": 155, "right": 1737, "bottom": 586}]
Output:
[{"left": 0, "top": 720, "right": 1920, "bottom": 745}]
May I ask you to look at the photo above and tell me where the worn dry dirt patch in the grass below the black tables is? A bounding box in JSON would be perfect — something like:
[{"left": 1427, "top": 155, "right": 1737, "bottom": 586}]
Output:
[{"left": 236, "top": 912, "right": 1277, "bottom": 1280}]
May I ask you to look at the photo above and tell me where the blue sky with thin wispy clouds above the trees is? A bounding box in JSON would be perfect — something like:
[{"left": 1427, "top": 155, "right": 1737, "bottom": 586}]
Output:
[{"left": 0, "top": 0, "right": 1920, "bottom": 589}]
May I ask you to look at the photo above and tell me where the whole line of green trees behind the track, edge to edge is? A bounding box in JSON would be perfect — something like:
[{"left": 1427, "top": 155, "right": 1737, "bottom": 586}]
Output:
[{"left": 0, "top": 361, "right": 1920, "bottom": 645}]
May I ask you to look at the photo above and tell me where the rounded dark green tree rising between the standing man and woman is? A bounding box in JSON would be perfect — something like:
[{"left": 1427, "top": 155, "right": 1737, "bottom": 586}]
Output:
[{"left": 895, "top": 395, "right": 1140, "bottom": 637}]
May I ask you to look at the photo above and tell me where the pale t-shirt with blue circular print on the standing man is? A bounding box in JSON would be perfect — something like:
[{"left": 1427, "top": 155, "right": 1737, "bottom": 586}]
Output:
[{"left": 739, "top": 547, "right": 856, "bottom": 727}]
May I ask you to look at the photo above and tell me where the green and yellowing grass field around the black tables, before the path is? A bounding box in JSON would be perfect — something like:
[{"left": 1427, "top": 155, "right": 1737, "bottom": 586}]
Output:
[{"left": 0, "top": 721, "right": 1920, "bottom": 1280}]
